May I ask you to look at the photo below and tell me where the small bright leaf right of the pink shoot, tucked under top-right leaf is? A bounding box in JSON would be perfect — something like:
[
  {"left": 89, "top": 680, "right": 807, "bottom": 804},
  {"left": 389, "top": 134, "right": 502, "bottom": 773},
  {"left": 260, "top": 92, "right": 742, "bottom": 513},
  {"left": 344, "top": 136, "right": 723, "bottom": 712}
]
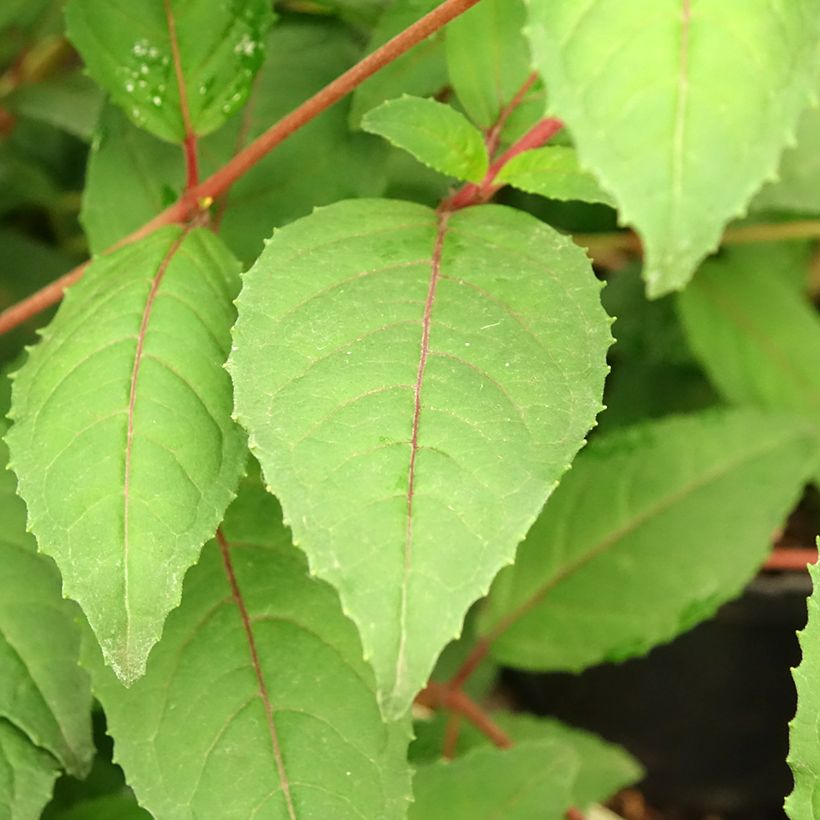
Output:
[{"left": 496, "top": 145, "right": 614, "bottom": 206}]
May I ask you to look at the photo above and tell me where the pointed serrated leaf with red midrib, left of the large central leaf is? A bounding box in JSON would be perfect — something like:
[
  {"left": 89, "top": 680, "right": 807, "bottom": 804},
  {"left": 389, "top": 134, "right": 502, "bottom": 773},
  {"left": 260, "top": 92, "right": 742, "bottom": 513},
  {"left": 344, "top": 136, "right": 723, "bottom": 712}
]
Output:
[{"left": 8, "top": 227, "right": 245, "bottom": 682}]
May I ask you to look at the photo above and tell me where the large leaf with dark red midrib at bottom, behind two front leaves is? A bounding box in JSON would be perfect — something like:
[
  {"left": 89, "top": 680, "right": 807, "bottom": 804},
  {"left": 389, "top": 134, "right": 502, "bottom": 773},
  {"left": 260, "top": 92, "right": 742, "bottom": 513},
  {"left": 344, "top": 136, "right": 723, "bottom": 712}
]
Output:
[{"left": 87, "top": 474, "right": 410, "bottom": 820}]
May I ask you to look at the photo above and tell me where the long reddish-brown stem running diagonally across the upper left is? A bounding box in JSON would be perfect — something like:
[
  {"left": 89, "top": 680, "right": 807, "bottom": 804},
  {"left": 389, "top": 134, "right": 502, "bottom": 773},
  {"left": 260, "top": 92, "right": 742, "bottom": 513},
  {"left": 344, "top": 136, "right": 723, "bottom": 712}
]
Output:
[{"left": 0, "top": 0, "right": 479, "bottom": 334}]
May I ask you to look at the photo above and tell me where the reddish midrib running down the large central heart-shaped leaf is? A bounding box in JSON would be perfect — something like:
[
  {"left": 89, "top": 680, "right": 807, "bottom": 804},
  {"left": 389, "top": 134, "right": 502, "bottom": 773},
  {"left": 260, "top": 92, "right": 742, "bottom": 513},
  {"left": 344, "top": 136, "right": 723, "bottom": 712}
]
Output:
[{"left": 394, "top": 211, "right": 451, "bottom": 686}]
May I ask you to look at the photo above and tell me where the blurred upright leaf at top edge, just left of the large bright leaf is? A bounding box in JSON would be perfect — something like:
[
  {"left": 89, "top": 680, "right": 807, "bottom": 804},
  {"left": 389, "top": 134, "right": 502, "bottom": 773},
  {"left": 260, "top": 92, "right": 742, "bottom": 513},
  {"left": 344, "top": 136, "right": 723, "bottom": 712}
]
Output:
[{"left": 446, "top": 0, "right": 532, "bottom": 128}]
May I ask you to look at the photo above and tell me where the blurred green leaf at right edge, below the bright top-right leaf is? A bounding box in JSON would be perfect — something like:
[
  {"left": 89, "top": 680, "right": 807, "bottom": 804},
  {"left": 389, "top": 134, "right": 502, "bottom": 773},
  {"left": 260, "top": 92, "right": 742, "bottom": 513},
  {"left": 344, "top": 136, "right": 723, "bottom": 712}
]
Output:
[{"left": 678, "top": 249, "right": 820, "bottom": 480}]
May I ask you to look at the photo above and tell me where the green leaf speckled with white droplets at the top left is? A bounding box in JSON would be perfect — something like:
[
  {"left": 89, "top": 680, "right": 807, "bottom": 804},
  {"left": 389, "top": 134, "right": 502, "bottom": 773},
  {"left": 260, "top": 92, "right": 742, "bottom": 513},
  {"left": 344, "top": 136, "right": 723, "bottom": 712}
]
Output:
[{"left": 66, "top": 0, "right": 273, "bottom": 142}]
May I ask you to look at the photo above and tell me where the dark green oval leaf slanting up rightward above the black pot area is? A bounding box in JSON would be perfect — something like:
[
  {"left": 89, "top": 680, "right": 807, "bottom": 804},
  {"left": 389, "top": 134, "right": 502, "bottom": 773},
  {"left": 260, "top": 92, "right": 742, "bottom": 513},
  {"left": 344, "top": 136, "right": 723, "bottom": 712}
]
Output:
[{"left": 481, "top": 410, "right": 818, "bottom": 671}]
